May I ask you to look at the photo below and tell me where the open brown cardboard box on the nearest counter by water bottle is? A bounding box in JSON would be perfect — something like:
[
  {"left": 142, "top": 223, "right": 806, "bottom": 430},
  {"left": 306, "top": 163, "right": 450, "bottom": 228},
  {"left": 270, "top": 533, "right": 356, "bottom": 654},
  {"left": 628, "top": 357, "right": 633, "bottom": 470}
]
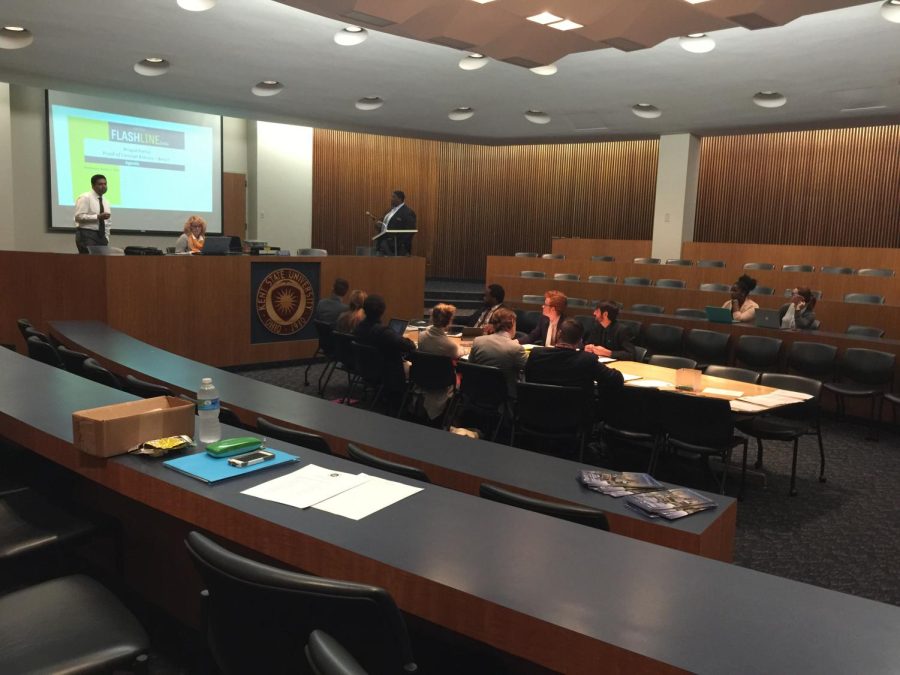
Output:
[{"left": 72, "top": 396, "right": 194, "bottom": 457}]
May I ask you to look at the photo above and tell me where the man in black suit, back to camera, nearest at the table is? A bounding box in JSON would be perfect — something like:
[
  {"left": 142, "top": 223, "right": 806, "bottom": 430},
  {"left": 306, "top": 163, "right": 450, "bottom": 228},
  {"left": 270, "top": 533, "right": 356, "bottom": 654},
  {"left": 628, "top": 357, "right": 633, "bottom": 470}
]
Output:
[{"left": 525, "top": 319, "right": 625, "bottom": 392}]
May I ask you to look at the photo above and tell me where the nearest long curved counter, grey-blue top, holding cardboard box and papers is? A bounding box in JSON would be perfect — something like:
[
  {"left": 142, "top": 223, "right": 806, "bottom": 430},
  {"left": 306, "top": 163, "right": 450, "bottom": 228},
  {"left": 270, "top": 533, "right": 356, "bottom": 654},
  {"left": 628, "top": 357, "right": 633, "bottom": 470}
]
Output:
[{"left": 0, "top": 350, "right": 900, "bottom": 675}]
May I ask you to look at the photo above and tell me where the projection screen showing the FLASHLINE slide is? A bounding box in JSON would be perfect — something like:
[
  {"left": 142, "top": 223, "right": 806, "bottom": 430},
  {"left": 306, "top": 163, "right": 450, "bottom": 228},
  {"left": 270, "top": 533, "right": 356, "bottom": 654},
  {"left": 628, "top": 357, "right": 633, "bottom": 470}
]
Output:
[{"left": 49, "top": 92, "right": 221, "bottom": 232}]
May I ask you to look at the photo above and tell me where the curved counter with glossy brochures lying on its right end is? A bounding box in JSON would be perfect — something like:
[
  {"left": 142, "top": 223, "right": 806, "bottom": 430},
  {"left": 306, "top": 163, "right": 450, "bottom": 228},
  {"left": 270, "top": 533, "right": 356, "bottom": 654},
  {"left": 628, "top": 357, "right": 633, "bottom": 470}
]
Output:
[{"left": 51, "top": 321, "right": 737, "bottom": 561}]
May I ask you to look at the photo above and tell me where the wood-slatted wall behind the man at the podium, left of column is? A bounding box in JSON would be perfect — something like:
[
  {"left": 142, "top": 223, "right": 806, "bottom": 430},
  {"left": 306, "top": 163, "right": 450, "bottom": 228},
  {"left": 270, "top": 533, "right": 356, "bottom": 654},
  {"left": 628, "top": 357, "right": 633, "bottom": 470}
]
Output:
[{"left": 313, "top": 129, "right": 659, "bottom": 279}]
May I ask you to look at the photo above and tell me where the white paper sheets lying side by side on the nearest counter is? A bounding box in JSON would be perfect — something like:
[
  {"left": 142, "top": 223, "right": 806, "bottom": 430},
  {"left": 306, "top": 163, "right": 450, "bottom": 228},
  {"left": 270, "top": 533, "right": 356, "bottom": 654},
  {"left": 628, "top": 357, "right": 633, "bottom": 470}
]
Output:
[{"left": 242, "top": 464, "right": 422, "bottom": 520}]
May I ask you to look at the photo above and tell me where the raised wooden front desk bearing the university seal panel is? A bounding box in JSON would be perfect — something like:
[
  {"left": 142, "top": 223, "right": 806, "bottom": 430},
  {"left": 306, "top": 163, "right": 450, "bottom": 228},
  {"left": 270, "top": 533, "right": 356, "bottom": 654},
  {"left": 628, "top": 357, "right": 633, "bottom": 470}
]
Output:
[{"left": 0, "top": 251, "right": 425, "bottom": 365}]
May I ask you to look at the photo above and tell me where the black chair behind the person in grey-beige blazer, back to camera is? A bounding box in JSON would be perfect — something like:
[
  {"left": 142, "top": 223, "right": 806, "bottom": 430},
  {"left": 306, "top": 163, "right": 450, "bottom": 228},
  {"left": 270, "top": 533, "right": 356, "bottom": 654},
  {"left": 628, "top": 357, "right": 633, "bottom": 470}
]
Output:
[{"left": 447, "top": 361, "right": 513, "bottom": 443}]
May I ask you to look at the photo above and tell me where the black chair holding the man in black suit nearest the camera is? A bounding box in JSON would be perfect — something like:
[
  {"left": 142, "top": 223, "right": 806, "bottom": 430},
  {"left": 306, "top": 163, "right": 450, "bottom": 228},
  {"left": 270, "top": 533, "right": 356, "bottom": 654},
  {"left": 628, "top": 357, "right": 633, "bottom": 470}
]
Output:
[{"left": 513, "top": 382, "right": 591, "bottom": 460}]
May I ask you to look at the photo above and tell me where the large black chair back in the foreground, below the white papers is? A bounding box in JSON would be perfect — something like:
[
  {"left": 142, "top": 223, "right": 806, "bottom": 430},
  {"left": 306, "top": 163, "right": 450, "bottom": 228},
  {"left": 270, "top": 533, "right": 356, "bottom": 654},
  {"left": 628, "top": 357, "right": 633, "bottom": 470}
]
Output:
[{"left": 185, "top": 532, "right": 417, "bottom": 675}]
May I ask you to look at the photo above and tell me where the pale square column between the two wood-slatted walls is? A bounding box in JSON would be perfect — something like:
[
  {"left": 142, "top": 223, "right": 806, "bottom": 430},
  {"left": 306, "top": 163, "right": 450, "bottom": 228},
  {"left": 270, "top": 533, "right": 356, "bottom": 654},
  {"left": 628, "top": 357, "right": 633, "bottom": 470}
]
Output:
[{"left": 651, "top": 134, "right": 700, "bottom": 261}]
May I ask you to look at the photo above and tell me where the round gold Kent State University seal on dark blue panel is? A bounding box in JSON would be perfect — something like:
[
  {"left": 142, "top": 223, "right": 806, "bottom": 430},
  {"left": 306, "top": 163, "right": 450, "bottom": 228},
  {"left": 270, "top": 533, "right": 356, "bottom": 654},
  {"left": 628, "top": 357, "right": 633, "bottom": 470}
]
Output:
[{"left": 256, "top": 268, "right": 315, "bottom": 335}]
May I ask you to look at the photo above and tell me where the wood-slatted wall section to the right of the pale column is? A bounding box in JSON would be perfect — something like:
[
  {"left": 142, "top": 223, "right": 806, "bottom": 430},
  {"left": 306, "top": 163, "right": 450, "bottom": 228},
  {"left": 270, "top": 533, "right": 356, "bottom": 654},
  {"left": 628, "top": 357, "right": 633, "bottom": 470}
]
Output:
[{"left": 694, "top": 125, "right": 900, "bottom": 248}]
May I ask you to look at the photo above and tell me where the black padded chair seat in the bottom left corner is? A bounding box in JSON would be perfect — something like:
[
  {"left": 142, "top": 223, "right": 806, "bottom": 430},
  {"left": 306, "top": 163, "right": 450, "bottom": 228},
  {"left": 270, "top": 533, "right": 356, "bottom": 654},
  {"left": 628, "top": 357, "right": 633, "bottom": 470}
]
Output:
[{"left": 0, "top": 574, "right": 150, "bottom": 673}]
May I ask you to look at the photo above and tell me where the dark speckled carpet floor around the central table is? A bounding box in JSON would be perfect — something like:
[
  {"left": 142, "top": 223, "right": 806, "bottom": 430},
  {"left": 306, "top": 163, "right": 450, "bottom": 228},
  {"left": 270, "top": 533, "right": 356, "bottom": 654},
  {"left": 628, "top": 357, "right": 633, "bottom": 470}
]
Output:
[{"left": 241, "top": 364, "right": 900, "bottom": 605}]
